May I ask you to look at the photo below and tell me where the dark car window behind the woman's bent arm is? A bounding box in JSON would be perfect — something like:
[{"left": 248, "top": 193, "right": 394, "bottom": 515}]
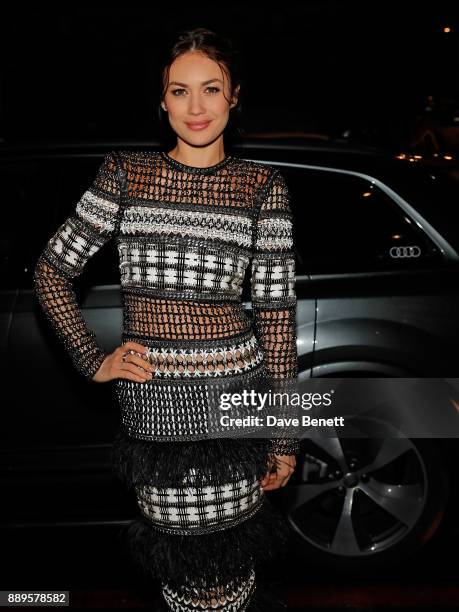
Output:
[{"left": 0, "top": 155, "right": 120, "bottom": 289}]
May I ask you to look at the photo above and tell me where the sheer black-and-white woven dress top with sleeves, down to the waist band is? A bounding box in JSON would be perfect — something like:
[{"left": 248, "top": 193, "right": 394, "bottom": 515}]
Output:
[{"left": 34, "top": 151, "right": 298, "bottom": 450}]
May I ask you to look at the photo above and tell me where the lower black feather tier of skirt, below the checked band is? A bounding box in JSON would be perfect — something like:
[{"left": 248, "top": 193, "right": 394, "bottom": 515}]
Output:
[{"left": 121, "top": 498, "right": 289, "bottom": 591}]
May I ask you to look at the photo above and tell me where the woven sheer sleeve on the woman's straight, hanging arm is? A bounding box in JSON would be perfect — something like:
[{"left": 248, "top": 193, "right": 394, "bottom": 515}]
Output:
[{"left": 251, "top": 169, "right": 299, "bottom": 455}]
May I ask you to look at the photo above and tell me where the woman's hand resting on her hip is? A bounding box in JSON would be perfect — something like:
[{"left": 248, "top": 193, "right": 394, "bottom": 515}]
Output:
[{"left": 92, "top": 342, "right": 154, "bottom": 382}]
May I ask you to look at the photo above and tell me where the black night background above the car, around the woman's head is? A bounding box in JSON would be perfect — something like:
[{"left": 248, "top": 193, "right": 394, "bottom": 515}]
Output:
[{"left": 0, "top": 0, "right": 459, "bottom": 144}]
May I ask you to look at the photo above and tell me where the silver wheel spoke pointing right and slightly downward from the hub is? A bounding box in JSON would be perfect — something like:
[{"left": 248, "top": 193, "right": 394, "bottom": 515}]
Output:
[{"left": 359, "top": 478, "right": 422, "bottom": 526}]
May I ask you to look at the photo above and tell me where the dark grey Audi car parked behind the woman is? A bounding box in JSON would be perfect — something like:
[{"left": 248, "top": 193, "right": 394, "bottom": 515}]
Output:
[{"left": 0, "top": 135, "right": 459, "bottom": 571}]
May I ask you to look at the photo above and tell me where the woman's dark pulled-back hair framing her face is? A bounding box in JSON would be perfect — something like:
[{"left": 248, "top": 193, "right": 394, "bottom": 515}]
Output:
[{"left": 158, "top": 28, "right": 244, "bottom": 147}]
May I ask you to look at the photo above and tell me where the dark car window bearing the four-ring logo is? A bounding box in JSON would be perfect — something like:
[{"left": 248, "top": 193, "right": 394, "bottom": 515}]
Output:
[{"left": 281, "top": 166, "right": 441, "bottom": 274}]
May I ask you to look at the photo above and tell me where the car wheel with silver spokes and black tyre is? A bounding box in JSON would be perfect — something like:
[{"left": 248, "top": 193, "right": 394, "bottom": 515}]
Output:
[{"left": 281, "top": 419, "right": 449, "bottom": 571}]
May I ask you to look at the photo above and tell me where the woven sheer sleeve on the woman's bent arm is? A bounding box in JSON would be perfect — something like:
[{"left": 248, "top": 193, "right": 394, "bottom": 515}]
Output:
[{"left": 34, "top": 153, "right": 120, "bottom": 381}]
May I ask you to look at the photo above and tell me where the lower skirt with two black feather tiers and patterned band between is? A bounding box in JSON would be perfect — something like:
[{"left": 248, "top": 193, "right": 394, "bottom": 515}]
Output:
[{"left": 112, "top": 429, "right": 289, "bottom": 612}]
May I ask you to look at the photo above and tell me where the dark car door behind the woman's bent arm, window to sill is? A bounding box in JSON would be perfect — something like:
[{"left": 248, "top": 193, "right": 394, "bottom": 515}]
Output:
[{"left": 0, "top": 152, "right": 135, "bottom": 533}]
